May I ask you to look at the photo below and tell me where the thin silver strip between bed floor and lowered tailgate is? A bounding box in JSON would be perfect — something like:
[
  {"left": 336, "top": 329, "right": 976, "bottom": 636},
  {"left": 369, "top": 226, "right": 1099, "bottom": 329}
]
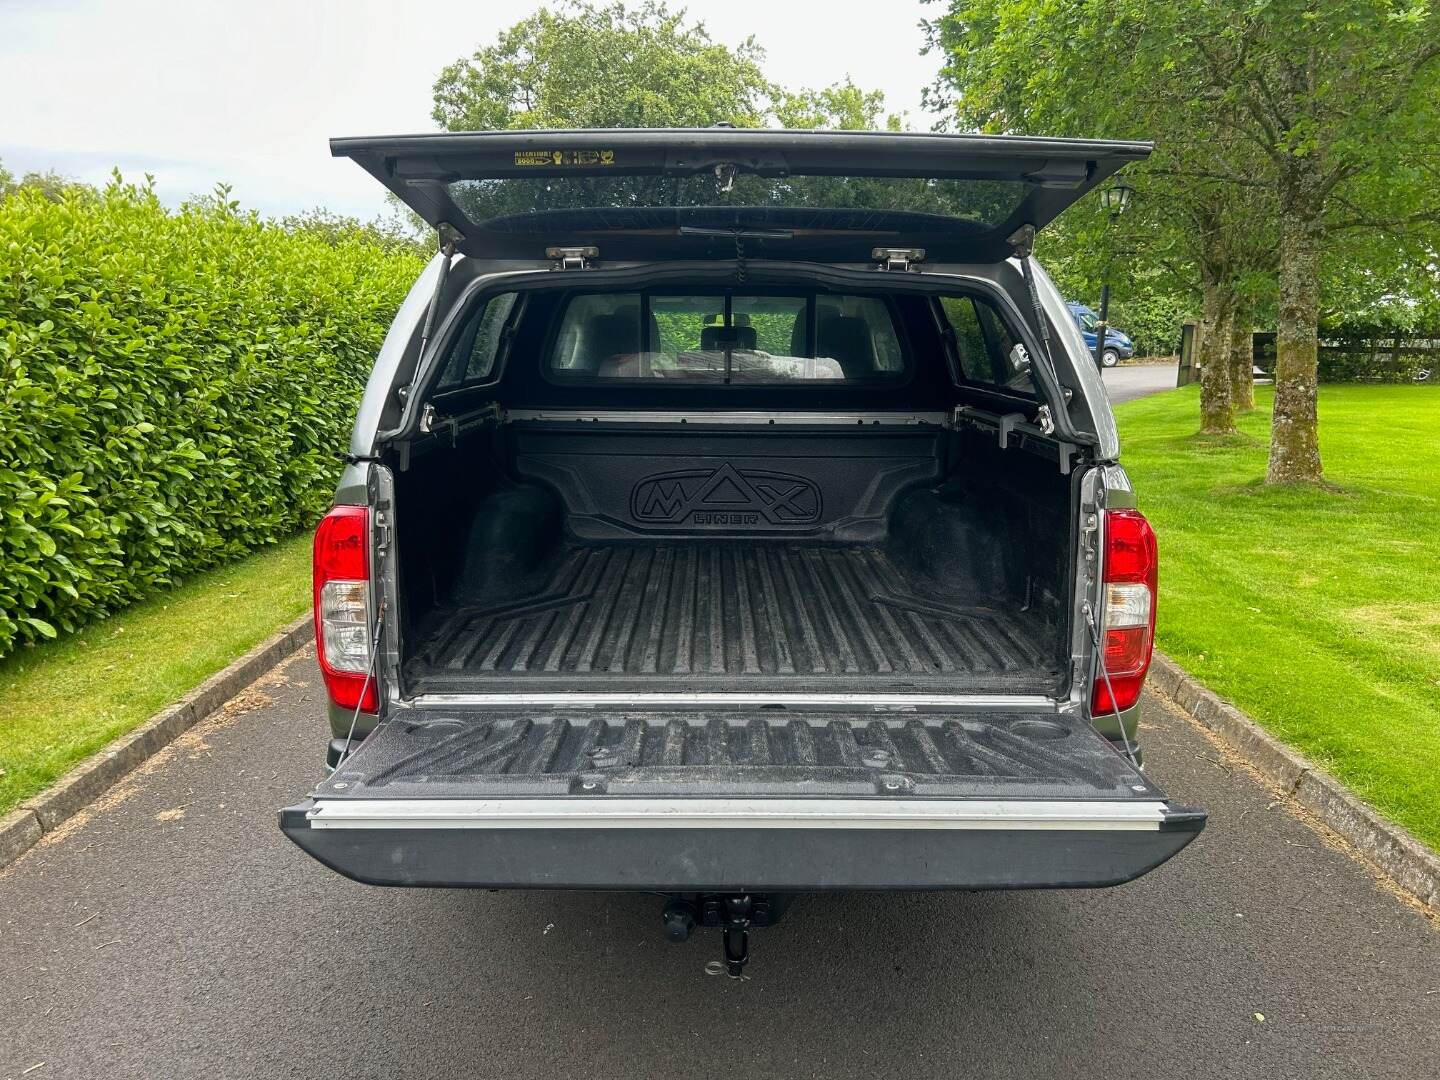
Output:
[{"left": 406, "top": 691, "right": 1058, "bottom": 713}]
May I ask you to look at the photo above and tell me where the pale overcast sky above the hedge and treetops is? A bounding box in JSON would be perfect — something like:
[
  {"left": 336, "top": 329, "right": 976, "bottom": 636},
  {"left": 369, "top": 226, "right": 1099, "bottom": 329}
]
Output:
[{"left": 0, "top": 0, "right": 937, "bottom": 217}]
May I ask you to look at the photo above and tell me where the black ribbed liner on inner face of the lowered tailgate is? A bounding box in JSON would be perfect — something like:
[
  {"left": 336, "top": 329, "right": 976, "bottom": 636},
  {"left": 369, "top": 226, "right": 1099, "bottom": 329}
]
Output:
[{"left": 317, "top": 708, "right": 1156, "bottom": 799}]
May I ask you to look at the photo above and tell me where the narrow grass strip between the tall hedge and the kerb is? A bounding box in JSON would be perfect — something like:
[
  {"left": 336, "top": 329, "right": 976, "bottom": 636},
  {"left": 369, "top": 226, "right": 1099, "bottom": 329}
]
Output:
[{"left": 0, "top": 536, "right": 310, "bottom": 814}]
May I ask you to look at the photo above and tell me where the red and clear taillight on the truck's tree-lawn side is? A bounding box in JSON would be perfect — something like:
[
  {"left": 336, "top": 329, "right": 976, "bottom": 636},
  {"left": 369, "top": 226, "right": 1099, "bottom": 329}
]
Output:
[{"left": 1090, "top": 510, "right": 1159, "bottom": 716}]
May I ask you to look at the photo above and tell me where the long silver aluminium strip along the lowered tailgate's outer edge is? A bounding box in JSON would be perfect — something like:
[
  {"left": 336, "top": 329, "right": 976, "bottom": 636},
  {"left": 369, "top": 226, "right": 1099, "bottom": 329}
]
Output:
[{"left": 305, "top": 796, "right": 1166, "bottom": 832}]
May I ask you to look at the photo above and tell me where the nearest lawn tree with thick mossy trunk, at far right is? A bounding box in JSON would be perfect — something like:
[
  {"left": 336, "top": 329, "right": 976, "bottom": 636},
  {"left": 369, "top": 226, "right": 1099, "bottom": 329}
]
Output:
[{"left": 1165, "top": 0, "right": 1440, "bottom": 482}]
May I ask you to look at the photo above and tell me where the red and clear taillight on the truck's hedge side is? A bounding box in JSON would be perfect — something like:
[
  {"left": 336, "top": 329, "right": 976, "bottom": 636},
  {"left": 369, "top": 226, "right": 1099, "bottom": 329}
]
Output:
[{"left": 315, "top": 507, "right": 379, "bottom": 713}]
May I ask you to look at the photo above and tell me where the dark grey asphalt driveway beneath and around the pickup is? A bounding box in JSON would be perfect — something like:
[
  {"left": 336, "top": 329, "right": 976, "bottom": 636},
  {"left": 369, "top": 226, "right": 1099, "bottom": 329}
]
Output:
[{"left": 0, "top": 651, "right": 1440, "bottom": 1080}]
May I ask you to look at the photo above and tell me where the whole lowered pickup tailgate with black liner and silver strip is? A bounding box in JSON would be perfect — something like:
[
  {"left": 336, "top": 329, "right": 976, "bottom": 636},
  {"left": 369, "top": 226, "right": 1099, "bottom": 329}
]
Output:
[{"left": 281, "top": 708, "right": 1205, "bottom": 891}]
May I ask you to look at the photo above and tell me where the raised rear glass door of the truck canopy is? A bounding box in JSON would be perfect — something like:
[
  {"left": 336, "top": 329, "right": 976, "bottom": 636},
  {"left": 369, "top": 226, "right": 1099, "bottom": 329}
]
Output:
[{"left": 330, "top": 127, "right": 1151, "bottom": 262}]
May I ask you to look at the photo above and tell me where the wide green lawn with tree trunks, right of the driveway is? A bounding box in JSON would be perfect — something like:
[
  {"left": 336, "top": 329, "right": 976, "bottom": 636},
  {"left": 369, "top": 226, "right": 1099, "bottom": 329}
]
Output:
[{"left": 1116, "top": 386, "right": 1440, "bottom": 848}]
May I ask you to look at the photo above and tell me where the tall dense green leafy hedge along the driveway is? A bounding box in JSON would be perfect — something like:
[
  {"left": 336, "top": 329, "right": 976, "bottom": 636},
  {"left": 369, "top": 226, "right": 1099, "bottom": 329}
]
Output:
[{"left": 0, "top": 179, "right": 420, "bottom": 655}]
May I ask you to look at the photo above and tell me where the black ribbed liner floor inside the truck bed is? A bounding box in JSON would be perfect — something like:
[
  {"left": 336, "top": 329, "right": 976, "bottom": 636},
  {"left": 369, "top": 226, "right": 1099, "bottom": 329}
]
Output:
[{"left": 406, "top": 541, "right": 1061, "bottom": 693}]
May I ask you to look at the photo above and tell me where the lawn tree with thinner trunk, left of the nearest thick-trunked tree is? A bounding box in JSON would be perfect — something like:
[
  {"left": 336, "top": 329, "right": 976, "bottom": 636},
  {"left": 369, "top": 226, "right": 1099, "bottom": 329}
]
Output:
[{"left": 926, "top": 0, "right": 1274, "bottom": 433}]
